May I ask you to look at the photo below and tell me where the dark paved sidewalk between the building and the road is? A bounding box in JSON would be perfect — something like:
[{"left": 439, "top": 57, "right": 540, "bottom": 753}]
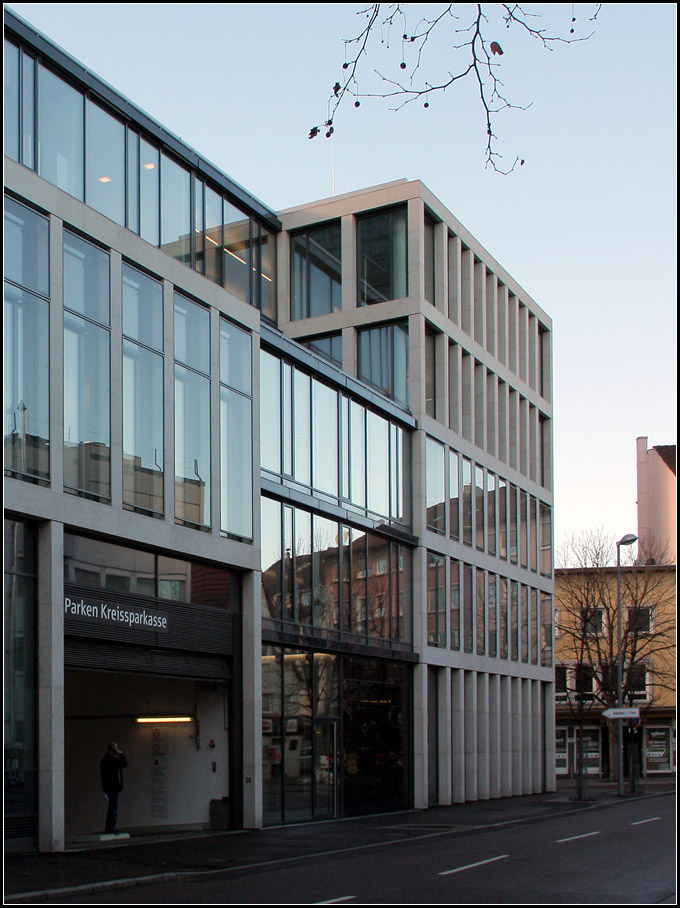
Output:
[{"left": 5, "top": 778, "right": 675, "bottom": 903}]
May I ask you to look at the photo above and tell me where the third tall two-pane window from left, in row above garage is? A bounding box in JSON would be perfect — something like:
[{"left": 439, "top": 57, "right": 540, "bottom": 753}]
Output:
[{"left": 123, "top": 265, "right": 164, "bottom": 514}]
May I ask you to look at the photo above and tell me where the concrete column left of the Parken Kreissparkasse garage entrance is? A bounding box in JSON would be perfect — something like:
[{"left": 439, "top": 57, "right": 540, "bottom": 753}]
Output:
[{"left": 36, "top": 522, "right": 65, "bottom": 851}]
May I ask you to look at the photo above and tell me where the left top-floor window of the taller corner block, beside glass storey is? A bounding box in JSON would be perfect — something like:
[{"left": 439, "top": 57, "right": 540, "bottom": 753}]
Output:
[{"left": 290, "top": 221, "right": 342, "bottom": 320}]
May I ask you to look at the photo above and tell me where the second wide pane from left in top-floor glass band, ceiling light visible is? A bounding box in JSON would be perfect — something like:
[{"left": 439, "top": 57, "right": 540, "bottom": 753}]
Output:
[{"left": 85, "top": 100, "right": 125, "bottom": 225}]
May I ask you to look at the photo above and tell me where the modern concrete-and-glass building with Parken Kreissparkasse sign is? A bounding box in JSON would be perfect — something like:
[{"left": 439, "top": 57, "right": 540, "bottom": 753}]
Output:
[{"left": 4, "top": 10, "right": 555, "bottom": 851}]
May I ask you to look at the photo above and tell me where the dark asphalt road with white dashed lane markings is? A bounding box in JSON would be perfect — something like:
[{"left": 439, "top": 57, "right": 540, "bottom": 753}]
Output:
[{"left": 50, "top": 794, "right": 676, "bottom": 905}]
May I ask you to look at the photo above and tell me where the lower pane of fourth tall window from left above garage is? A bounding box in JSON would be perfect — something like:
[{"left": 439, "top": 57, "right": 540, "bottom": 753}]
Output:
[{"left": 175, "top": 365, "right": 210, "bottom": 526}]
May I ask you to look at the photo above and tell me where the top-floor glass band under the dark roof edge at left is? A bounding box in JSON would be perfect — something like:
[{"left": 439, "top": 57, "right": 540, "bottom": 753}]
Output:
[{"left": 5, "top": 46, "right": 276, "bottom": 321}]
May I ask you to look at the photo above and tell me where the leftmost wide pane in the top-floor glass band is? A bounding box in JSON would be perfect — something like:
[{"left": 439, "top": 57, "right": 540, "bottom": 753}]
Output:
[{"left": 38, "top": 66, "right": 85, "bottom": 200}]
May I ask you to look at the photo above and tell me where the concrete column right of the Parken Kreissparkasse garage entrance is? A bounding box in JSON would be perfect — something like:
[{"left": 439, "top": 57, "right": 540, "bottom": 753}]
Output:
[{"left": 243, "top": 571, "right": 262, "bottom": 829}]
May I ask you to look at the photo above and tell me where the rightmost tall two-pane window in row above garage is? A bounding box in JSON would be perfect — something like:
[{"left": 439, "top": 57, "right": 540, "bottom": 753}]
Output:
[{"left": 220, "top": 319, "right": 253, "bottom": 539}]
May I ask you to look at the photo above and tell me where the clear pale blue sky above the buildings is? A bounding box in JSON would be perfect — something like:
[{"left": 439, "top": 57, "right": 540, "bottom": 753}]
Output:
[{"left": 10, "top": 3, "right": 677, "bottom": 546}]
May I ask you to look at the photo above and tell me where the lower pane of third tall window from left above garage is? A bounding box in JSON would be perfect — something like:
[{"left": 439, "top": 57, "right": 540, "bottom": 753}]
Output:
[{"left": 123, "top": 340, "right": 164, "bottom": 514}]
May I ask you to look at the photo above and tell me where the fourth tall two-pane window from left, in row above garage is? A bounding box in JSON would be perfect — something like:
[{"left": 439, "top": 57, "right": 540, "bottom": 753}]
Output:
[{"left": 175, "top": 293, "right": 211, "bottom": 526}]
